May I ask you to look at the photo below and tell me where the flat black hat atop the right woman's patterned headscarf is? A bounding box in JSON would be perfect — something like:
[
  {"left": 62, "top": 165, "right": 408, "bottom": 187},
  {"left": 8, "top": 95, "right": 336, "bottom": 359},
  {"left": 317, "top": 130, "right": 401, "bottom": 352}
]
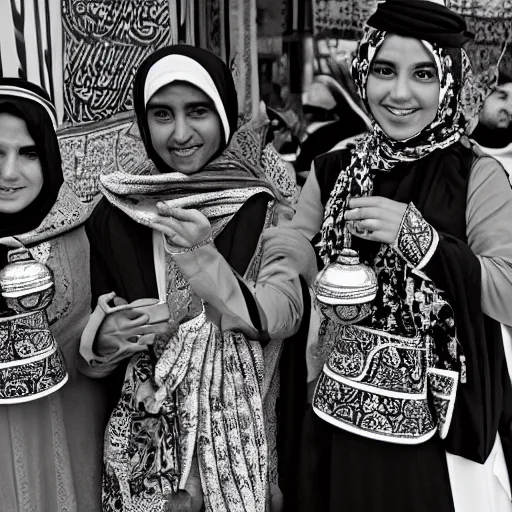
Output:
[{"left": 367, "top": 0, "right": 473, "bottom": 48}]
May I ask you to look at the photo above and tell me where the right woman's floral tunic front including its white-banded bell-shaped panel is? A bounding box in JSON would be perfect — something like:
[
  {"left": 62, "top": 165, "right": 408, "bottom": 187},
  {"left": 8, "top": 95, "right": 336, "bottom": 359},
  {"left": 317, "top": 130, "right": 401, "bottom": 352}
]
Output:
[{"left": 313, "top": 242, "right": 462, "bottom": 444}]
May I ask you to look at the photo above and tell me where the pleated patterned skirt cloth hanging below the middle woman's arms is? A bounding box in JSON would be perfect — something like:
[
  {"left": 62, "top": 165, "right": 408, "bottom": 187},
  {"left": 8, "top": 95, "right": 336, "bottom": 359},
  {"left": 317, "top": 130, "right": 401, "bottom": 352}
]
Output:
[{"left": 103, "top": 209, "right": 279, "bottom": 512}]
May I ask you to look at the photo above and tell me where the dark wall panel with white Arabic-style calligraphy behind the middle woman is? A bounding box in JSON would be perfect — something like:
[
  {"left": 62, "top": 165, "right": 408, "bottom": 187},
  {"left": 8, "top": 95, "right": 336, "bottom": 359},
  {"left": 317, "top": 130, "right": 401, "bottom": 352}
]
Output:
[{"left": 62, "top": 0, "right": 171, "bottom": 123}]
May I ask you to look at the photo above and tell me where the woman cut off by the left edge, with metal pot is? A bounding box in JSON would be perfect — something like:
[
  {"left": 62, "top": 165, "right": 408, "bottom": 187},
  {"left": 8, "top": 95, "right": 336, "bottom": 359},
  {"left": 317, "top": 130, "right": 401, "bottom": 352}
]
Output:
[{"left": 0, "top": 78, "right": 108, "bottom": 512}]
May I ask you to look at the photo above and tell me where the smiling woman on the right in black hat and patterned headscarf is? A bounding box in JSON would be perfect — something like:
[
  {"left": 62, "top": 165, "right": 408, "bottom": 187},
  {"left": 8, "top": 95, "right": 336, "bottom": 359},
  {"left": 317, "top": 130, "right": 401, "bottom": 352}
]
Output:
[{"left": 276, "top": 0, "right": 512, "bottom": 512}]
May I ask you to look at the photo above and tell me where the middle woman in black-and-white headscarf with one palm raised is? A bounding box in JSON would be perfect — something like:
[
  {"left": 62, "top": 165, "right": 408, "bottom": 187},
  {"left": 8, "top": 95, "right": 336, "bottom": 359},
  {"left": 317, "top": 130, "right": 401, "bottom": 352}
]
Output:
[{"left": 82, "top": 45, "right": 314, "bottom": 512}]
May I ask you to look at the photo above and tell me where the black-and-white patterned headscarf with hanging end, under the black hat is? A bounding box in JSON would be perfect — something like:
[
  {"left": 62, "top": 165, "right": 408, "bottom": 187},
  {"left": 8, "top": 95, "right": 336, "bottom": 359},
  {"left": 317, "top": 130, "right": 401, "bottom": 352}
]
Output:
[{"left": 320, "top": 27, "right": 471, "bottom": 262}]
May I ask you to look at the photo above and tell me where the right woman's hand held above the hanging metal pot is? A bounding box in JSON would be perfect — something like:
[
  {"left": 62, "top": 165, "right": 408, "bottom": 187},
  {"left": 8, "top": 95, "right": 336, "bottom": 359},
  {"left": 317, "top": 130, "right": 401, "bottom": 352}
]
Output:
[{"left": 345, "top": 196, "right": 407, "bottom": 244}]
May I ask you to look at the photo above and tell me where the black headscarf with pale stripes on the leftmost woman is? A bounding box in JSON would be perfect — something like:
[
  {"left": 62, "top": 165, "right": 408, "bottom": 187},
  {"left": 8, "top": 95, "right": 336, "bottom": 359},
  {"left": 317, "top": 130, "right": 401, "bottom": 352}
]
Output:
[{"left": 0, "top": 78, "right": 64, "bottom": 237}]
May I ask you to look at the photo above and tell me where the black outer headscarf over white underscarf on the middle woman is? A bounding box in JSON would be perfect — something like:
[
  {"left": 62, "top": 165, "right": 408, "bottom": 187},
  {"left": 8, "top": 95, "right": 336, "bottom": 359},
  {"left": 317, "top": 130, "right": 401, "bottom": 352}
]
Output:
[{"left": 133, "top": 45, "right": 238, "bottom": 172}]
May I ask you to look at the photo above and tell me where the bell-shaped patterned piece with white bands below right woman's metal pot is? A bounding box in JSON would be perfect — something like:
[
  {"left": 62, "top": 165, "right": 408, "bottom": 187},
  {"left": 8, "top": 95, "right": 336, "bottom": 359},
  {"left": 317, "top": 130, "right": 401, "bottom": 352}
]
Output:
[{"left": 313, "top": 326, "right": 440, "bottom": 444}]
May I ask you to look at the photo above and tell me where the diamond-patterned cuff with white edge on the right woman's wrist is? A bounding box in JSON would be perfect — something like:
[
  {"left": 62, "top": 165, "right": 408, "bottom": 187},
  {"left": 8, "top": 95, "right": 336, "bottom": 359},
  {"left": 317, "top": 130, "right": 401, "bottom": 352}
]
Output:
[{"left": 391, "top": 203, "right": 439, "bottom": 269}]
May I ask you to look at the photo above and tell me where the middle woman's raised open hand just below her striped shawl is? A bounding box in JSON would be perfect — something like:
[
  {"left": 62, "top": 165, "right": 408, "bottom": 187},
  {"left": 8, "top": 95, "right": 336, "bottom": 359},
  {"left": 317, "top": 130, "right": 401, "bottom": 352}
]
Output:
[{"left": 151, "top": 203, "right": 212, "bottom": 249}]
